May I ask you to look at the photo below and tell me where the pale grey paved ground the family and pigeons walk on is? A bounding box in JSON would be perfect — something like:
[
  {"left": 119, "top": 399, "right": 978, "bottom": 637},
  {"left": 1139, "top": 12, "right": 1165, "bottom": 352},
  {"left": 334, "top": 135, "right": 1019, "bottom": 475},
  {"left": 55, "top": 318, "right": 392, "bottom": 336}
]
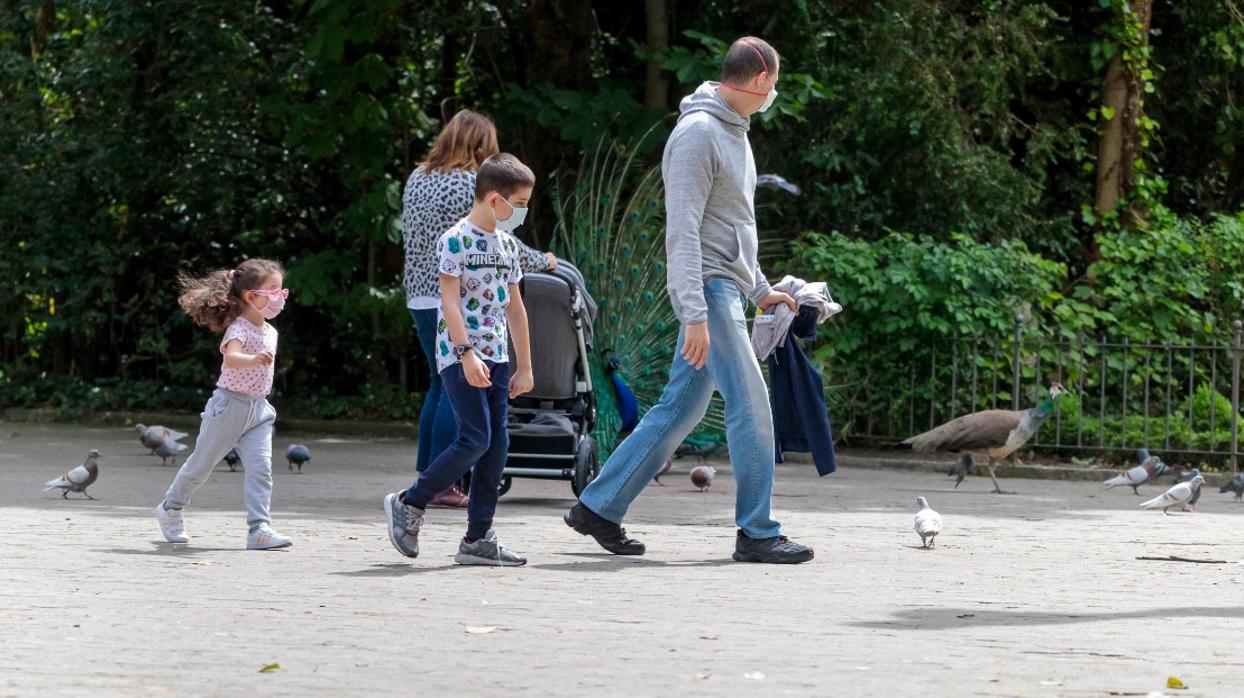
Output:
[{"left": 0, "top": 423, "right": 1244, "bottom": 697}]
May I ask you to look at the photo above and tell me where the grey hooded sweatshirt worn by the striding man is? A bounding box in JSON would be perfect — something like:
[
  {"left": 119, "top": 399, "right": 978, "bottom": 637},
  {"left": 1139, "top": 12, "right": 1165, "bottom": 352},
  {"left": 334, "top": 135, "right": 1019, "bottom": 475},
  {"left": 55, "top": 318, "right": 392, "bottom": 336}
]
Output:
[{"left": 661, "top": 82, "right": 769, "bottom": 325}]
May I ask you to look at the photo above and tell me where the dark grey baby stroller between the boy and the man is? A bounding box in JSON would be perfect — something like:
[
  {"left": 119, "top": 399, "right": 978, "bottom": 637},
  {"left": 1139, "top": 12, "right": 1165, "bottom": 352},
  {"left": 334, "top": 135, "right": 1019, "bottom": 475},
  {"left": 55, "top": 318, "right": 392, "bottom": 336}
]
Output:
[{"left": 500, "top": 260, "right": 601, "bottom": 496}]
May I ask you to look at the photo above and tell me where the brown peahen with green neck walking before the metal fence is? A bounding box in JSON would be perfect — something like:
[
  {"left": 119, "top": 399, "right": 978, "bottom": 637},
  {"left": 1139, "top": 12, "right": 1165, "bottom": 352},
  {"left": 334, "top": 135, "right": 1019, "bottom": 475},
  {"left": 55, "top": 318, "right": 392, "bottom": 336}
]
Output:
[{"left": 898, "top": 383, "right": 1067, "bottom": 494}]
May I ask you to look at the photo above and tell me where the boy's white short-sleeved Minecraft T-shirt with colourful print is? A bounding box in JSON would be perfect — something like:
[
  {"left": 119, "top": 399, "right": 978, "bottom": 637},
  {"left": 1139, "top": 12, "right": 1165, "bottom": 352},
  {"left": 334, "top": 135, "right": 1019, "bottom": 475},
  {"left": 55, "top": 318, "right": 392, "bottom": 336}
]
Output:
[{"left": 437, "top": 218, "right": 522, "bottom": 371}]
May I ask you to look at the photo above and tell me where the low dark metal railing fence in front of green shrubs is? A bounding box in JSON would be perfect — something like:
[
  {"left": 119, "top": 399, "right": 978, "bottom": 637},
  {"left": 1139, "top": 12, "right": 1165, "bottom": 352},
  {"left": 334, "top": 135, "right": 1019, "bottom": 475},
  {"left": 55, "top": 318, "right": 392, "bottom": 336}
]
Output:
[{"left": 835, "top": 317, "right": 1244, "bottom": 472}]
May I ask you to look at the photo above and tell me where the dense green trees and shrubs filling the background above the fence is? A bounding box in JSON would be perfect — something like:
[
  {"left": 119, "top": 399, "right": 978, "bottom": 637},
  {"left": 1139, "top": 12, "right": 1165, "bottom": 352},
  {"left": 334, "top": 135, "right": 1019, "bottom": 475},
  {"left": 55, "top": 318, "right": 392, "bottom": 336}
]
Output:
[{"left": 0, "top": 0, "right": 1244, "bottom": 416}]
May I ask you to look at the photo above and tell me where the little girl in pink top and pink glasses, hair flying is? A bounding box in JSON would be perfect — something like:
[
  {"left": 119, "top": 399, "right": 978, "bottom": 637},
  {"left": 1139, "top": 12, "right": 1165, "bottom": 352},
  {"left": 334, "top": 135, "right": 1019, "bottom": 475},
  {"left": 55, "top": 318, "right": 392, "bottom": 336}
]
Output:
[{"left": 156, "top": 259, "right": 292, "bottom": 550}]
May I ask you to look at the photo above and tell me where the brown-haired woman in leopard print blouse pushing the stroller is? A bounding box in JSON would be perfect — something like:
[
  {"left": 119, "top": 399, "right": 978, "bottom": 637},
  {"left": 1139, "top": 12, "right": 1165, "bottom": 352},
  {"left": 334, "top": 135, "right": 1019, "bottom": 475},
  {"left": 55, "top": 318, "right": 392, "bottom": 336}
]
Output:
[{"left": 402, "top": 109, "right": 557, "bottom": 508}]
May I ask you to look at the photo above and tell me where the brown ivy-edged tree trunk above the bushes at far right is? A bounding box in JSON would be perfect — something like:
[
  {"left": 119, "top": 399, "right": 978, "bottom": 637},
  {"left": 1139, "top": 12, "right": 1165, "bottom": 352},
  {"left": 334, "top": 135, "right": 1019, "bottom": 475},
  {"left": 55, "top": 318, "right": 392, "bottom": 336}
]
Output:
[{"left": 1092, "top": 0, "right": 1153, "bottom": 222}]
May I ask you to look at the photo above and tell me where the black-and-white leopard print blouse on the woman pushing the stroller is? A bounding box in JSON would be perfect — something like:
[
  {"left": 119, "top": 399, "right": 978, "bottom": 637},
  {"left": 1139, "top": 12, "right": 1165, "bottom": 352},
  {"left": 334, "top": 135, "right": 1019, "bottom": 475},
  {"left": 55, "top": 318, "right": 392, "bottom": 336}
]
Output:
[{"left": 402, "top": 167, "right": 549, "bottom": 309}]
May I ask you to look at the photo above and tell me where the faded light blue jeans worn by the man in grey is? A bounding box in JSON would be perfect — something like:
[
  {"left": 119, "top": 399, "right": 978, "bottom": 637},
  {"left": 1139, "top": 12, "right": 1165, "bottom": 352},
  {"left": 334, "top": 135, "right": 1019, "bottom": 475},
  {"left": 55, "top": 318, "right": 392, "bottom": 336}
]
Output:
[{"left": 578, "top": 279, "right": 781, "bottom": 539}]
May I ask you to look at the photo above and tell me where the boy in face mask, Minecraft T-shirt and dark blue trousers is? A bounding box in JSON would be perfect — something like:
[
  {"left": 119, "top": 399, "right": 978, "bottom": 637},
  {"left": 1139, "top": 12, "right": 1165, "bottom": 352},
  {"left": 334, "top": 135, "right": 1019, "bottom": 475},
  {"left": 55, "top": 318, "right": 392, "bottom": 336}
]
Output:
[{"left": 384, "top": 153, "right": 535, "bottom": 566}]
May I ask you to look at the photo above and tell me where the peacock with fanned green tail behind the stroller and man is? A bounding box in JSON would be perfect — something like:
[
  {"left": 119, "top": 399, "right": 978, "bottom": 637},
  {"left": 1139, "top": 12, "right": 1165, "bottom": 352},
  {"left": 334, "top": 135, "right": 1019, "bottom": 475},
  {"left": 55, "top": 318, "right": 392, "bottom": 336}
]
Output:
[{"left": 554, "top": 141, "right": 725, "bottom": 457}]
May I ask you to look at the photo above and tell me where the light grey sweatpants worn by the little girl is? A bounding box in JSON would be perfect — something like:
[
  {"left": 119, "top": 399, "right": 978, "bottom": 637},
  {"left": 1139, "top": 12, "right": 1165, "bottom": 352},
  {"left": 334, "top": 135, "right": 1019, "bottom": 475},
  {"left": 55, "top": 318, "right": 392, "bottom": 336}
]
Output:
[{"left": 164, "top": 388, "right": 276, "bottom": 530}]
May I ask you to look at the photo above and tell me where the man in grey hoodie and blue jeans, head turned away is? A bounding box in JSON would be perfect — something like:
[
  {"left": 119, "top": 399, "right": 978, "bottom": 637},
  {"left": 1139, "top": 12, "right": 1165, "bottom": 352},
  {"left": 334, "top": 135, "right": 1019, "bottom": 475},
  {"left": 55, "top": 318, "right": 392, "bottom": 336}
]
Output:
[{"left": 565, "top": 36, "right": 812, "bottom": 562}]
